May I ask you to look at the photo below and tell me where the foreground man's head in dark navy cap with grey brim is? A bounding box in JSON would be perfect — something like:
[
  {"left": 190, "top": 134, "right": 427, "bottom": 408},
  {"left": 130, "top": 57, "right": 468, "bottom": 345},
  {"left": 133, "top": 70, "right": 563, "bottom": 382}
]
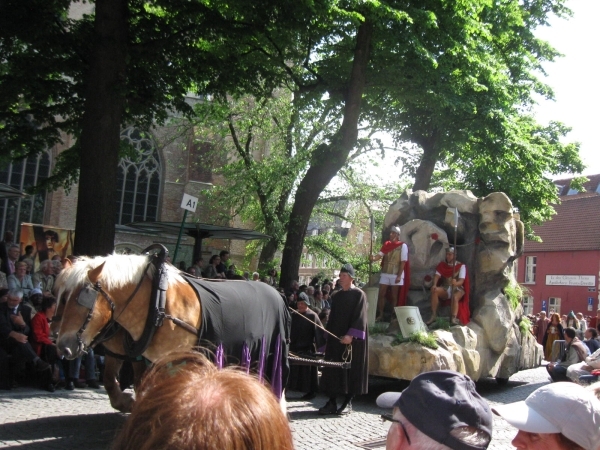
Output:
[{"left": 377, "top": 370, "right": 492, "bottom": 450}]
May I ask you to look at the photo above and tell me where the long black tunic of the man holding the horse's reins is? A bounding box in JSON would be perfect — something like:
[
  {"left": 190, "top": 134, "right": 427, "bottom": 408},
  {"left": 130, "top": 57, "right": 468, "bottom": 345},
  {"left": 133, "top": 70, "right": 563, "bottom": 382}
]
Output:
[{"left": 321, "top": 288, "right": 369, "bottom": 396}]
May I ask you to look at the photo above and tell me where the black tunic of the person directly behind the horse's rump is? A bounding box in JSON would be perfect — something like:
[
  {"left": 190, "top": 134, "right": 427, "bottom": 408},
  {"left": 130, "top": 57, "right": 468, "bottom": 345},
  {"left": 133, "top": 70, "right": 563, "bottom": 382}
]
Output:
[{"left": 288, "top": 309, "right": 325, "bottom": 392}]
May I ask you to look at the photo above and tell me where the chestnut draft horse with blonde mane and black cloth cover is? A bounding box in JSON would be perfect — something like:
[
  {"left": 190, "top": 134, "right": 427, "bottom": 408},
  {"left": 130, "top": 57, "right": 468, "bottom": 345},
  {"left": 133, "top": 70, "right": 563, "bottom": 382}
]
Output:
[{"left": 56, "top": 250, "right": 290, "bottom": 407}]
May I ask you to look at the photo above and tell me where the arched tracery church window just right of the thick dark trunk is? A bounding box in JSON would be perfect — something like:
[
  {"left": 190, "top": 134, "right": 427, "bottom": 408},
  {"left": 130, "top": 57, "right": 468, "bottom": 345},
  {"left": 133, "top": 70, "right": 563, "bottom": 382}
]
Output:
[{"left": 117, "top": 127, "right": 160, "bottom": 225}]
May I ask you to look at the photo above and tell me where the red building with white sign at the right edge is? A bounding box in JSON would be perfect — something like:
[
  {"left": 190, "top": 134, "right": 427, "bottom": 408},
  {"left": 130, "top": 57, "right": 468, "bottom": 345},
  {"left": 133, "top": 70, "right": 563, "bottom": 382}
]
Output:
[{"left": 517, "top": 175, "right": 600, "bottom": 315}]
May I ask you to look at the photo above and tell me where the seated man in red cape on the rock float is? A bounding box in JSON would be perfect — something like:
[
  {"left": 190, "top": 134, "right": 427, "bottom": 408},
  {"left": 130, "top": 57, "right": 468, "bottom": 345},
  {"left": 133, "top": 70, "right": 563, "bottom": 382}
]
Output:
[{"left": 427, "top": 247, "right": 471, "bottom": 325}]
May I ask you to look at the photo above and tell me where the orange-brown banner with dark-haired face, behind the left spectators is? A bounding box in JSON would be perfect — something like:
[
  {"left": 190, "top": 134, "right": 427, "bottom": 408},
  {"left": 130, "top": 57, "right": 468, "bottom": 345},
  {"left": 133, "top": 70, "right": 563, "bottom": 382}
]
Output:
[{"left": 20, "top": 223, "right": 75, "bottom": 268}]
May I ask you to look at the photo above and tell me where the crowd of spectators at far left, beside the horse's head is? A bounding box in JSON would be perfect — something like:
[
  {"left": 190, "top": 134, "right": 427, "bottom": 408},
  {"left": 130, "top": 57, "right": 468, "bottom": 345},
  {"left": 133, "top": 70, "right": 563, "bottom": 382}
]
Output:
[{"left": 0, "top": 232, "right": 100, "bottom": 392}]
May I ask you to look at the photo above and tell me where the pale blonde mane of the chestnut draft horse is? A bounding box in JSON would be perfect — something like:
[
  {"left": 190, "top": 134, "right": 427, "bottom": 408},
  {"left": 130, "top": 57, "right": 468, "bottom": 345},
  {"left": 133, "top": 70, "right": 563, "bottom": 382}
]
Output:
[{"left": 56, "top": 253, "right": 185, "bottom": 298}]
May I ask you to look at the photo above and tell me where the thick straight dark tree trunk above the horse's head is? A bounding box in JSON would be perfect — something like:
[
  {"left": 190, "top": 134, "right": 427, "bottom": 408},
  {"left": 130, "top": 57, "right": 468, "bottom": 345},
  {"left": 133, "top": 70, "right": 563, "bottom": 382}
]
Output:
[{"left": 74, "top": 0, "right": 128, "bottom": 255}]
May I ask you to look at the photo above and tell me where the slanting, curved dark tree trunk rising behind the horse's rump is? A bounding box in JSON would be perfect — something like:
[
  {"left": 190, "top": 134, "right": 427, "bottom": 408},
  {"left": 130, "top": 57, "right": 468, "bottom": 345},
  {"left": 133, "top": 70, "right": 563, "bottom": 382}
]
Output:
[{"left": 279, "top": 21, "right": 373, "bottom": 288}]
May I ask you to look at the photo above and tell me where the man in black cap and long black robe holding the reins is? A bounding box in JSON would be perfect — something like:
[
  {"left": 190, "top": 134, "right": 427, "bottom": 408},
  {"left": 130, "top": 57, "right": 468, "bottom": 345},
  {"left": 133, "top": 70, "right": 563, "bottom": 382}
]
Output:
[{"left": 319, "top": 264, "right": 369, "bottom": 415}]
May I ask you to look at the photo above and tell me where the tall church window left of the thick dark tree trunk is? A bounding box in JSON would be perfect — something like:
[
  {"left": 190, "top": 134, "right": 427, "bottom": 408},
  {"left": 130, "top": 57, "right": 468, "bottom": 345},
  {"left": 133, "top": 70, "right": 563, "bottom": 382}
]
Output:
[{"left": 0, "top": 152, "right": 50, "bottom": 241}]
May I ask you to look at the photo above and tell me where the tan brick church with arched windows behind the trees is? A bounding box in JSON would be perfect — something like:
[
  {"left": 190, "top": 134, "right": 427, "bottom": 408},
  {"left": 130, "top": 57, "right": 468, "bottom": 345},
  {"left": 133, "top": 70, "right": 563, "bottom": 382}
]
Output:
[{"left": 0, "top": 117, "right": 251, "bottom": 265}]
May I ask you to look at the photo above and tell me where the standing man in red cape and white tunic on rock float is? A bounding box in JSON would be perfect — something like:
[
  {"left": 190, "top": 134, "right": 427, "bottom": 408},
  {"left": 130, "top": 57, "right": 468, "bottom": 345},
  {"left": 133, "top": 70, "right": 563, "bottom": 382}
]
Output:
[{"left": 370, "top": 226, "right": 410, "bottom": 321}]
